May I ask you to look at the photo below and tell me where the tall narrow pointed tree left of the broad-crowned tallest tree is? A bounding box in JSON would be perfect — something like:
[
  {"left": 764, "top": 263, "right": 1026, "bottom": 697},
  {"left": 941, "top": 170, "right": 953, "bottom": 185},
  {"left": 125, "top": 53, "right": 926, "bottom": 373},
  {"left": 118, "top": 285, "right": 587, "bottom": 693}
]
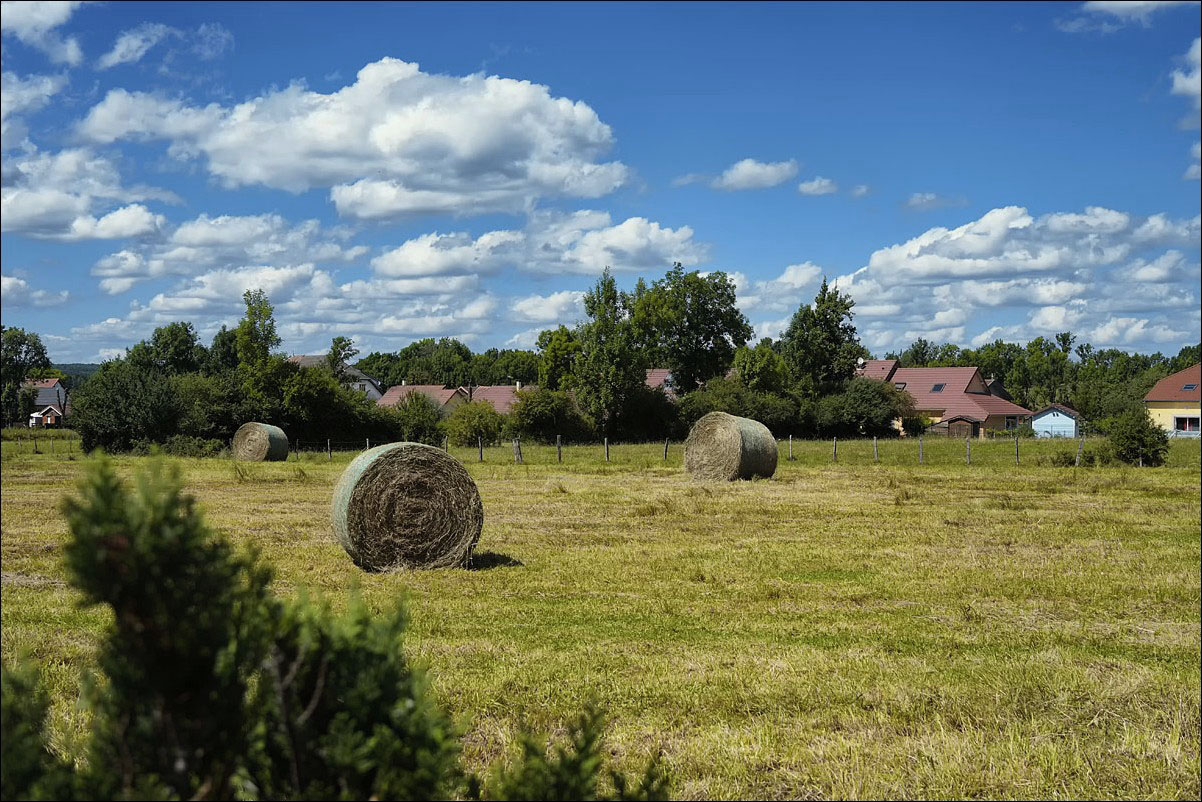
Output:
[{"left": 571, "top": 268, "right": 647, "bottom": 435}]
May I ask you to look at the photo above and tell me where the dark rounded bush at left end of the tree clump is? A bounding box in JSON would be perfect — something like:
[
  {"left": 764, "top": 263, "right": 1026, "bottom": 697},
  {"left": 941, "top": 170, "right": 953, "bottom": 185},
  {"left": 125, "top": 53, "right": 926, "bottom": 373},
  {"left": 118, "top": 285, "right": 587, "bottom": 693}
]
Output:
[{"left": 71, "top": 360, "right": 179, "bottom": 451}]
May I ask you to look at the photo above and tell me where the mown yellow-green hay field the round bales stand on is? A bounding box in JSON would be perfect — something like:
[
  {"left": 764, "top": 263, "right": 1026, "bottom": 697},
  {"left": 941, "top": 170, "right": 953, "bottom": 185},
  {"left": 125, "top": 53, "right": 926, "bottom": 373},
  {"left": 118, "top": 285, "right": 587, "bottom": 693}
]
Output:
[{"left": 0, "top": 438, "right": 1202, "bottom": 798}]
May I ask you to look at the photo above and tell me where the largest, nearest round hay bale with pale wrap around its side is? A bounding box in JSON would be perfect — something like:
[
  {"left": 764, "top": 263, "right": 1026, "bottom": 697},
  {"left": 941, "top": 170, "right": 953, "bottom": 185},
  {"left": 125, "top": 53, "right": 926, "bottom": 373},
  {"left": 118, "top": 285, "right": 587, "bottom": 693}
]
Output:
[{"left": 333, "top": 442, "right": 484, "bottom": 571}]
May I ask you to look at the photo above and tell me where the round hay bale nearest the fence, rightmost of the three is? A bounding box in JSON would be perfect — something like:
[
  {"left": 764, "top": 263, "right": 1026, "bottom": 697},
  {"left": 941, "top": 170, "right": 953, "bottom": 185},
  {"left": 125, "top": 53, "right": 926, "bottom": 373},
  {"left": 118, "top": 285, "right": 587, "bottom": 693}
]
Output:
[{"left": 684, "top": 412, "right": 776, "bottom": 482}]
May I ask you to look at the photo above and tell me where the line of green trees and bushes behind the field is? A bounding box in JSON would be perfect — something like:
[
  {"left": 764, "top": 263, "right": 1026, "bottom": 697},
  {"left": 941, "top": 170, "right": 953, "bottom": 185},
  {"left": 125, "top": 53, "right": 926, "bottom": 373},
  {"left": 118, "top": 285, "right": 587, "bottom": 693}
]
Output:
[{"left": 2, "top": 263, "right": 1200, "bottom": 453}]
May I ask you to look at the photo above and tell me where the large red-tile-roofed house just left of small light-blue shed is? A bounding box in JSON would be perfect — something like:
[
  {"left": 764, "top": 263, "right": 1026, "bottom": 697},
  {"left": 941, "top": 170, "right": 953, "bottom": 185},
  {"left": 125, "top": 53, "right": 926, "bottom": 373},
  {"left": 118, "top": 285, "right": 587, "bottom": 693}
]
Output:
[{"left": 857, "top": 360, "right": 1031, "bottom": 438}]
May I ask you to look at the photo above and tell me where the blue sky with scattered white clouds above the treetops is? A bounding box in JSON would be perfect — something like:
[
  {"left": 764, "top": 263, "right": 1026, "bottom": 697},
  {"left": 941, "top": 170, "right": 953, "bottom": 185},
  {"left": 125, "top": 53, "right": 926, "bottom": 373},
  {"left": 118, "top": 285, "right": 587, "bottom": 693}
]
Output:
[{"left": 0, "top": 1, "right": 1200, "bottom": 362}]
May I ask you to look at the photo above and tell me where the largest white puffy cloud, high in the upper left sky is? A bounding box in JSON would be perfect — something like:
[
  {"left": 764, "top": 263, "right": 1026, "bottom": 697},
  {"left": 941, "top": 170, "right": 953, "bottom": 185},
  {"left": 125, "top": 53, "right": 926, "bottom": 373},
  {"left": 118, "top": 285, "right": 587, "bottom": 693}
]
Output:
[{"left": 77, "top": 58, "right": 629, "bottom": 219}]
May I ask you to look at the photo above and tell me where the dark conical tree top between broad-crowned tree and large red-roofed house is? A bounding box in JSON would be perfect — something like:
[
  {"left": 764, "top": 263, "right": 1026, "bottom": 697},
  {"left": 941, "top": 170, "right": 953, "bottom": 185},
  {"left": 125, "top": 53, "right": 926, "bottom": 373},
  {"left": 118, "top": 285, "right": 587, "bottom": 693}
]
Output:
[{"left": 779, "top": 278, "right": 869, "bottom": 394}]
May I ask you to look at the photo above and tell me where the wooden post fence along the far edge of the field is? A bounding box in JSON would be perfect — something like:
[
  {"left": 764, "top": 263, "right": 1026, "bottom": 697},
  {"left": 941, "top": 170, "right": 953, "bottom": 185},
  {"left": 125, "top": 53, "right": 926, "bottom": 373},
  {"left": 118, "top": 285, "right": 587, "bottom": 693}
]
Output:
[{"left": 292, "top": 434, "right": 1101, "bottom": 467}]
